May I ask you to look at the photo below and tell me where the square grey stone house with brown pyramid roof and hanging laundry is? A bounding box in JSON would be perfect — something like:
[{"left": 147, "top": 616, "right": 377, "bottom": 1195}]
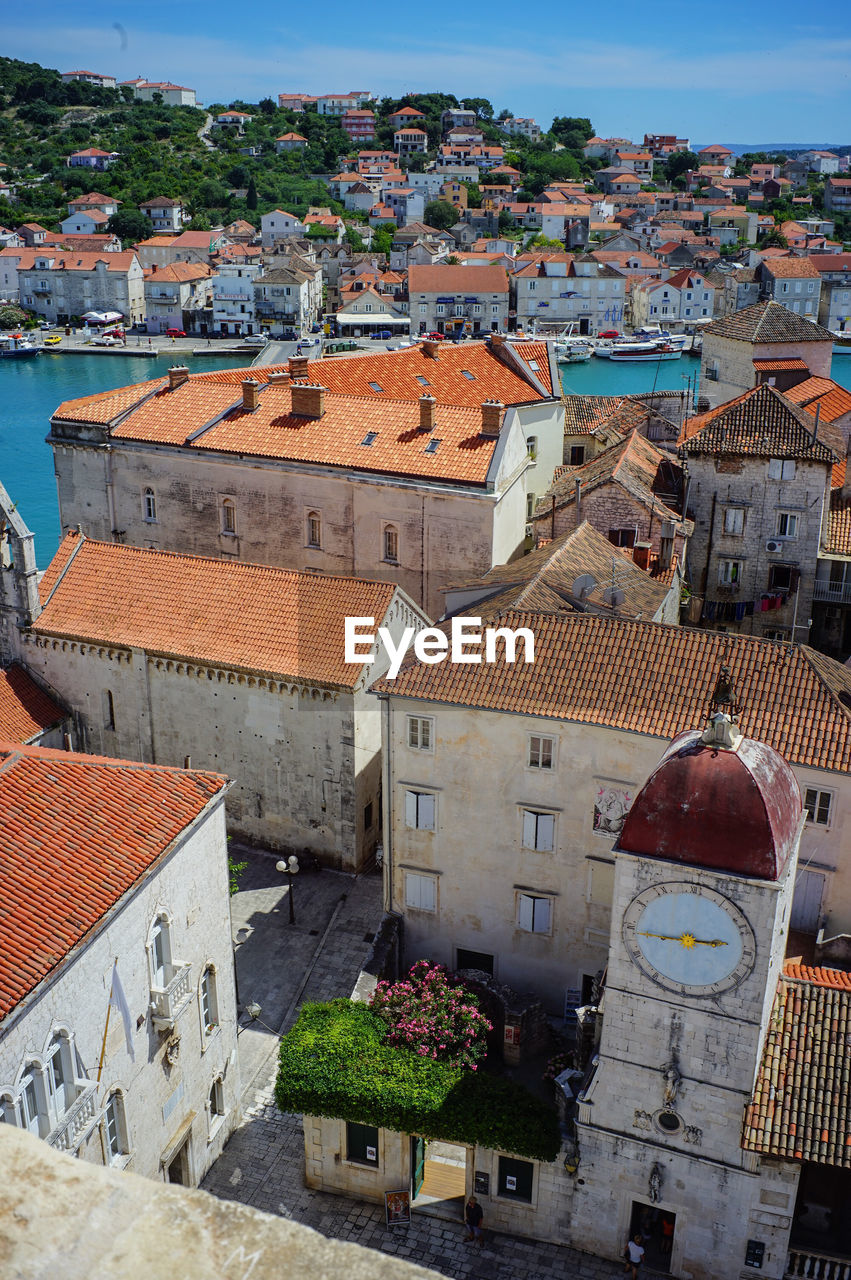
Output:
[{"left": 681, "top": 384, "right": 845, "bottom": 640}]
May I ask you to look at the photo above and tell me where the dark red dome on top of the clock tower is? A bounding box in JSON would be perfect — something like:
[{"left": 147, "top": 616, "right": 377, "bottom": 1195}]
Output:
[{"left": 618, "top": 731, "right": 801, "bottom": 879}]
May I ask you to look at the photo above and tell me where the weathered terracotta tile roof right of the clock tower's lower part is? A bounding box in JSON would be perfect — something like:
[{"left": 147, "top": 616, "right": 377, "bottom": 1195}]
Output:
[{"left": 742, "top": 969, "right": 851, "bottom": 1169}]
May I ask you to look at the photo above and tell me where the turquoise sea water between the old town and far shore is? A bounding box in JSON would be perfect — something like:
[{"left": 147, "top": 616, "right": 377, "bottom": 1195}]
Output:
[{"left": 0, "top": 355, "right": 851, "bottom": 568}]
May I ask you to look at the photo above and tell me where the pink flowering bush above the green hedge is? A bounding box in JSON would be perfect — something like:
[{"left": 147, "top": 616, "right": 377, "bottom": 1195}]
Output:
[{"left": 370, "top": 960, "right": 491, "bottom": 1071}]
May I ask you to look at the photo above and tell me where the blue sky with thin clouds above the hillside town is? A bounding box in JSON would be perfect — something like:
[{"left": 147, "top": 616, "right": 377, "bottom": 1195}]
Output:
[{"left": 6, "top": 0, "right": 851, "bottom": 143}]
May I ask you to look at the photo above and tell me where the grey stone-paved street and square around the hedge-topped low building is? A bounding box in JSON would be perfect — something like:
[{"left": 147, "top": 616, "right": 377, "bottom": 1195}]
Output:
[{"left": 202, "top": 845, "right": 622, "bottom": 1280}]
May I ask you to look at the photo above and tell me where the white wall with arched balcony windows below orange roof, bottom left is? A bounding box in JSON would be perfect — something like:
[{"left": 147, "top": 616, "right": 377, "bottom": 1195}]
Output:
[{"left": 0, "top": 801, "right": 239, "bottom": 1185}]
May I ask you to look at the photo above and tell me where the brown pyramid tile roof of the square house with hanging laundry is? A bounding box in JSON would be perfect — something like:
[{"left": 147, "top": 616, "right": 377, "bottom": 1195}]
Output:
[{"left": 680, "top": 383, "right": 837, "bottom": 465}]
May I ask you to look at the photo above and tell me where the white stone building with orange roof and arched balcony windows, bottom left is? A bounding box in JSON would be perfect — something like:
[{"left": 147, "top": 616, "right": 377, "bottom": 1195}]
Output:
[{"left": 0, "top": 744, "right": 241, "bottom": 1187}]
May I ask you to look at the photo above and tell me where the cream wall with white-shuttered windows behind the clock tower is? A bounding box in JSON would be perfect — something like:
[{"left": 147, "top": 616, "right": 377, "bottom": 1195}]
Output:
[{"left": 384, "top": 696, "right": 851, "bottom": 993}]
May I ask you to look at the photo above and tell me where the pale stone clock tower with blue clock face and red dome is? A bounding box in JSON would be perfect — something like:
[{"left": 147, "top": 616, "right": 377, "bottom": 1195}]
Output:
[{"left": 571, "top": 704, "right": 804, "bottom": 1280}]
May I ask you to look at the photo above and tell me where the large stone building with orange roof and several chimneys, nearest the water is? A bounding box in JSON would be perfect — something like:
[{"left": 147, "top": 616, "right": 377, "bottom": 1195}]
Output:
[{"left": 51, "top": 340, "right": 563, "bottom": 617}]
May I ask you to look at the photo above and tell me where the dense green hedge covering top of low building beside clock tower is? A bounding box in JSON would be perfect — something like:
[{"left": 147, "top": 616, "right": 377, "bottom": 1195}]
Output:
[{"left": 275, "top": 1000, "right": 561, "bottom": 1161}]
